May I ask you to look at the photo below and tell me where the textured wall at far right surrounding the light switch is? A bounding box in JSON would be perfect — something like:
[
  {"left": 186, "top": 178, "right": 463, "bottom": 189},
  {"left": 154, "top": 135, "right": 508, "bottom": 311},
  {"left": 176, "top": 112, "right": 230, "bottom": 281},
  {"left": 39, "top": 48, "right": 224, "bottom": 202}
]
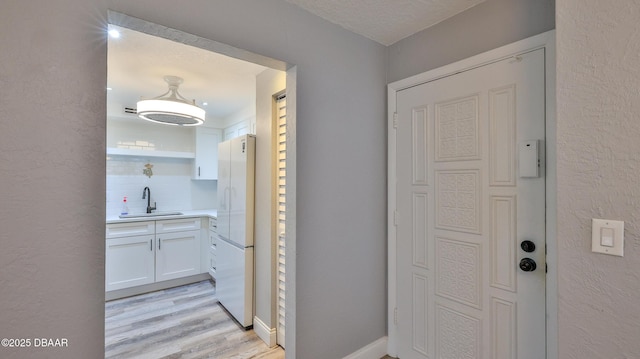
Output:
[{"left": 557, "top": 0, "right": 640, "bottom": 359}]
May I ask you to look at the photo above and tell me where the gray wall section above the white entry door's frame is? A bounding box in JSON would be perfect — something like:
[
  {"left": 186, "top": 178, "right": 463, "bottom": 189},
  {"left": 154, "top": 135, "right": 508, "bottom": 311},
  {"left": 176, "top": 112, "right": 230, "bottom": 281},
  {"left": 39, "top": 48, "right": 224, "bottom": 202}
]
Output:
[{"left": 388, "top": 0, "right": 555, "bottom": 82}]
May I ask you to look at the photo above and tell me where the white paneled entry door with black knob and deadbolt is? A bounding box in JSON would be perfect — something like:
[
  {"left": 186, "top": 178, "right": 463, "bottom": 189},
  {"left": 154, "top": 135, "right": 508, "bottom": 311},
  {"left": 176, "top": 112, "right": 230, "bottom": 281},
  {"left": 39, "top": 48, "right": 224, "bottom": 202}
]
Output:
[{"left": 396, "top": 49, "right": 546, "bottom": 359}]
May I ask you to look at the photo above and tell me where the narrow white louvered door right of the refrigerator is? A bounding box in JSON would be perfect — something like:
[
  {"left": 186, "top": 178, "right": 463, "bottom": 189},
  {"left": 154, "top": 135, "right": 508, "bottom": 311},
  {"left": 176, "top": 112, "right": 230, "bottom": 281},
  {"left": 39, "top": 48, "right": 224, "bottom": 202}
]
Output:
[{"left": 276, "top": 96, "right": 287, "bottom": 348}]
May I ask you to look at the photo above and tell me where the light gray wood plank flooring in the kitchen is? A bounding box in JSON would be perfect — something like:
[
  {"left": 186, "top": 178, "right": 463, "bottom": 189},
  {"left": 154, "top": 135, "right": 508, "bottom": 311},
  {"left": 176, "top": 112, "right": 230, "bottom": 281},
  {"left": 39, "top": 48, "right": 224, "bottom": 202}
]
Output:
[{"left": 105, "top": 281, "right": 284, "bottom": 359}]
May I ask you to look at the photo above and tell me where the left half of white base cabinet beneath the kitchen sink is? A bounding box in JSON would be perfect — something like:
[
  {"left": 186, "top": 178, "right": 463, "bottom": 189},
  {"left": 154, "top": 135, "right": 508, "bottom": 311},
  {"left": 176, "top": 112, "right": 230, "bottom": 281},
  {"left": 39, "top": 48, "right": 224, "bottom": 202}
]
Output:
[{"left": 105, "top": 221, "right": 155, "bottom": 291}]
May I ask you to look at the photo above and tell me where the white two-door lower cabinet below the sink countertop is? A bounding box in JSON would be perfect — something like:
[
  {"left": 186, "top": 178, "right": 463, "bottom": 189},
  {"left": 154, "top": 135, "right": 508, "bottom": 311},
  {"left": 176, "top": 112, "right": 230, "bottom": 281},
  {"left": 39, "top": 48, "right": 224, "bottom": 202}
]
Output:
[{"left": 105, "top": 218, "right": 201, "bottom": 291}]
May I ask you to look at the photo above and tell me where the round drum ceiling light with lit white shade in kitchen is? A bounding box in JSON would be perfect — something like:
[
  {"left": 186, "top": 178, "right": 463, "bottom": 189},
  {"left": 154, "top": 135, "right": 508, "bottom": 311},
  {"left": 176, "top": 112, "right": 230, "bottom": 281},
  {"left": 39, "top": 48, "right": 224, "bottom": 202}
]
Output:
[{"left": 137, "top": 76, "right": 205, "bottom": 126}]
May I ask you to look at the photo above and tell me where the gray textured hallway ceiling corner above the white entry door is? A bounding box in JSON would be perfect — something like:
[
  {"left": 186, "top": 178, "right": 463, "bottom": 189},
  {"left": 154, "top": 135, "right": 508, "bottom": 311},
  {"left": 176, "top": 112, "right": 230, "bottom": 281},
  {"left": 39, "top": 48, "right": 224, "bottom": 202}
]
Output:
[{"left": 286, "top": 0, "right": 485, "bottom": 45}]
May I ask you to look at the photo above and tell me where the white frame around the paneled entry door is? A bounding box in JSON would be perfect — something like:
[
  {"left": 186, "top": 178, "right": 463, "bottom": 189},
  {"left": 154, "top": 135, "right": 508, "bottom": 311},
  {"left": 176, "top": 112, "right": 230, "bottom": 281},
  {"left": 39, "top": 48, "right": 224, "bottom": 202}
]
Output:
[{"left": 387, "top": 30, "right": 558, "bottom": 359}]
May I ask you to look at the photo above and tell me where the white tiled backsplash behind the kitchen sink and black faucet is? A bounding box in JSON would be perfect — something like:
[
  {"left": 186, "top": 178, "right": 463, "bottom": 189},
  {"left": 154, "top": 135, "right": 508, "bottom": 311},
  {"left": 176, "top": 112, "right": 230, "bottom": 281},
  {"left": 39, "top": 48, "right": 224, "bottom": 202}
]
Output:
[{"left": 106, "top": 156, "right": 217, "bottom": 217}]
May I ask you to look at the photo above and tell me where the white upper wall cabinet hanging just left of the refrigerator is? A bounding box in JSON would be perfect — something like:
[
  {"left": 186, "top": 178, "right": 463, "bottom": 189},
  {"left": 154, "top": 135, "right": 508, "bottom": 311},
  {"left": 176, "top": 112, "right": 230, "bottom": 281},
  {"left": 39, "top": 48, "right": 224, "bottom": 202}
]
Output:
[{"left": 193, "top": 127, "right": 222, "bottom": 180}]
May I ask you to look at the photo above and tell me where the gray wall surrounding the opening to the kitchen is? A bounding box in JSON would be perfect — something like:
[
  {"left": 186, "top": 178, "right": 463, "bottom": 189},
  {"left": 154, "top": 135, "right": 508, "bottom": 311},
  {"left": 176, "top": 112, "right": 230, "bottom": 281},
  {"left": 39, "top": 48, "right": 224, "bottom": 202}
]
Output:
[{"left": 0, "top": 0, "right": 386, "bottom": 359}]
